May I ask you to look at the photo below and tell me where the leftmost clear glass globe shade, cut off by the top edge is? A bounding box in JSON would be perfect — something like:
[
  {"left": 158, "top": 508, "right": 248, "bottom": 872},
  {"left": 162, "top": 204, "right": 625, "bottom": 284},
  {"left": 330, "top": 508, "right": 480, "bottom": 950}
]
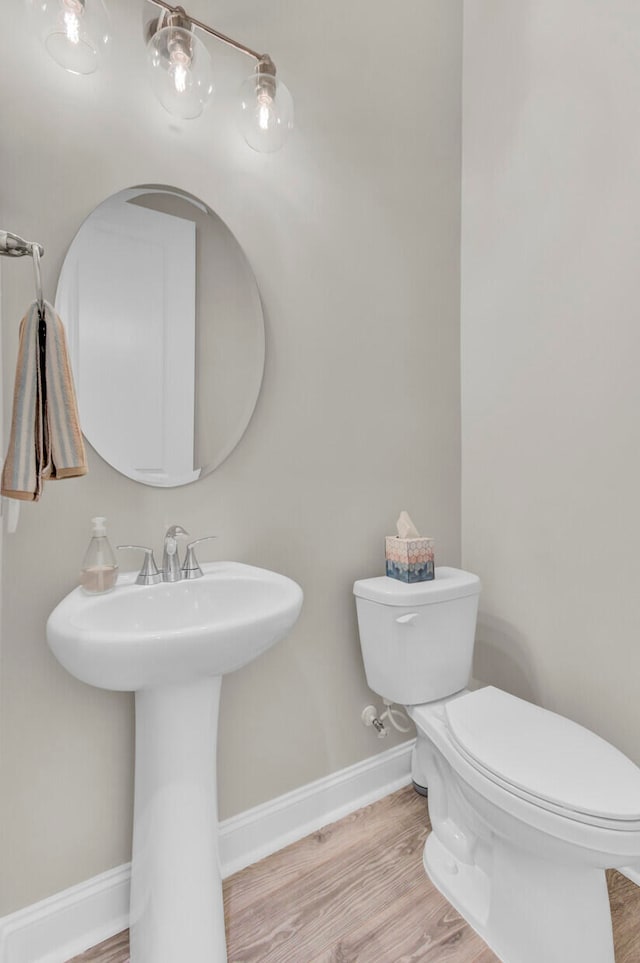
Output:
[{"left": 34, "top": 0, "right": 109, "bottom": 74}]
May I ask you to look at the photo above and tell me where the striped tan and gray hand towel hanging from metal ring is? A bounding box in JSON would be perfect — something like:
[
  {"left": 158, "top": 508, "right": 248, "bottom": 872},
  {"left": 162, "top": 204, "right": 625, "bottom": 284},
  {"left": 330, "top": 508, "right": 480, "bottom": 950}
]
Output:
[{"left": 2, "top": 302, "right": 87, "bottom": 501}]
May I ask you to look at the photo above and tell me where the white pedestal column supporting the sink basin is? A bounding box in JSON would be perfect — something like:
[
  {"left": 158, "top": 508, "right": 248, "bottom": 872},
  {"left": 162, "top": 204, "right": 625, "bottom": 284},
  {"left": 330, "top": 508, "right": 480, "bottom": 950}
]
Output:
[{"left": 131, "top": 677, "right": 227, "bottom": 963}]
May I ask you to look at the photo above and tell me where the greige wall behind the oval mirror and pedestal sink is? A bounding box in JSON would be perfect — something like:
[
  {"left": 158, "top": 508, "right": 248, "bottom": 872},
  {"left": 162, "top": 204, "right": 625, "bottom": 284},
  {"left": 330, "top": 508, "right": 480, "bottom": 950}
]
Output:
[{"left": 0, "top": 0, "right": 461, "bottom": 914}]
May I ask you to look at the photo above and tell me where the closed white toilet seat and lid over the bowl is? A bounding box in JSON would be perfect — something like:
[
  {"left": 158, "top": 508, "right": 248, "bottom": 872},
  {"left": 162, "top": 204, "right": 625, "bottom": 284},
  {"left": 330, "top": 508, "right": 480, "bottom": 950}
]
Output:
[{"left": 444, "top": 686, "right": 640, "bottom": 831}]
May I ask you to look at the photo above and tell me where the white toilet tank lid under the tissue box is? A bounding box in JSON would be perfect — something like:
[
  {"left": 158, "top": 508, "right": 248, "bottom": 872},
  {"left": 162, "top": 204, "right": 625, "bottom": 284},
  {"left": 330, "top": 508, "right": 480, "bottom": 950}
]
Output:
[{"left": 353, "top": 565, "right": 481, "bottom": 606}]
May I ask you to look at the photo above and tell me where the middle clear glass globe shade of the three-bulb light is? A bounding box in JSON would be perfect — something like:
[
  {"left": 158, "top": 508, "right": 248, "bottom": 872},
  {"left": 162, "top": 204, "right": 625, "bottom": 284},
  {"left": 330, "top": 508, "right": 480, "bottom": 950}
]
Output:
[{"left": 147, "top": 26, "right": 213, "bottom": 120}]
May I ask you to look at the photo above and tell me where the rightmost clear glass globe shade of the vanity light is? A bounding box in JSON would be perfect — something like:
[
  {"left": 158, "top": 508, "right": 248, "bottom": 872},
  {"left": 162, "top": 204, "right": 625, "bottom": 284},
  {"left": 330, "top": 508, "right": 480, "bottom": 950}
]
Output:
[{"left": 238, "top": 73, "right": 293, "bottom": 154}]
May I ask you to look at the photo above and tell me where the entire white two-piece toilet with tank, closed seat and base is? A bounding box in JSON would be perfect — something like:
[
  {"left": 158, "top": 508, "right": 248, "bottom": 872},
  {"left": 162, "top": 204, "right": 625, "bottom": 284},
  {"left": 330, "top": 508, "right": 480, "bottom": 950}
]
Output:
[{"left": 353, "top": 568, "right": 640, "bottom": 963}]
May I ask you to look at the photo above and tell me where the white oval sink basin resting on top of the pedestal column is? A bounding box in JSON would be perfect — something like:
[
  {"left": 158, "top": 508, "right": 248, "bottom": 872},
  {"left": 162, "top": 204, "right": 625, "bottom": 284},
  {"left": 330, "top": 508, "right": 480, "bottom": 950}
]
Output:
[{"left": 47, "top": 562, "right": 302, "bottom": 690}]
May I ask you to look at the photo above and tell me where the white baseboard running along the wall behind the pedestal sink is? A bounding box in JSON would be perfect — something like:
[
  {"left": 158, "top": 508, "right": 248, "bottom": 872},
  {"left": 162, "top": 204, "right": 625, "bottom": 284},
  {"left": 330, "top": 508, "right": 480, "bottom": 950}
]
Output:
[{"left": 0, "top": 739, "right": 415, "bottom": 963}]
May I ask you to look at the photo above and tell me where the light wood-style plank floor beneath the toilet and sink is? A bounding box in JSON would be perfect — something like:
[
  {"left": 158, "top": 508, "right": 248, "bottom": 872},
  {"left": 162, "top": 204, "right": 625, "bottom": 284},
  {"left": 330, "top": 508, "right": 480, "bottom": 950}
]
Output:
[{"left": 70, "top": 787, "right": 640, "bottom": 963}]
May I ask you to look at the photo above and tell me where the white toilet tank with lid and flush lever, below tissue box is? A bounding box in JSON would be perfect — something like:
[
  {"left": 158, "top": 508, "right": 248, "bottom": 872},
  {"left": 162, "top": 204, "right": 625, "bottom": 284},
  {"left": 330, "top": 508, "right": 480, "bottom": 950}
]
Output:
[{"left": 353, "top": 566, "right": 481, "bottom": 706}]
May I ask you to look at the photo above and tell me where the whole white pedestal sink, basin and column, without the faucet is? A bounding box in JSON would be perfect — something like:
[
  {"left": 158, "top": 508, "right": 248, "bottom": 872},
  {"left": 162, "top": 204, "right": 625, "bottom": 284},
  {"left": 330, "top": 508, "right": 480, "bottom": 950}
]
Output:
[{"left": 47, "top": 562, "right": 302, "bottom": 963}]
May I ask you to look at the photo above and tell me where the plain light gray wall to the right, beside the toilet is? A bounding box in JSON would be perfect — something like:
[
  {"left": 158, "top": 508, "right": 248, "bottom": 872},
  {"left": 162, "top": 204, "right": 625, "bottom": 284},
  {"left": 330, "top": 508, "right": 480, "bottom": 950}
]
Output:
[{"left": 462, "top": 0, "right": 640, "bottom": 763}]
